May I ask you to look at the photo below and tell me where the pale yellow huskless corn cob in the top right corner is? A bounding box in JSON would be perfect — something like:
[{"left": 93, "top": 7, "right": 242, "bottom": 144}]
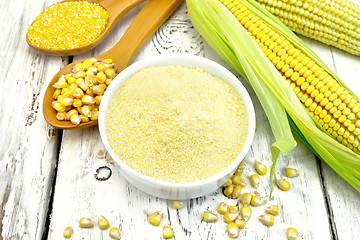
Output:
[{"left": 256, "top": 0, "right": 360, "bottom": 56}]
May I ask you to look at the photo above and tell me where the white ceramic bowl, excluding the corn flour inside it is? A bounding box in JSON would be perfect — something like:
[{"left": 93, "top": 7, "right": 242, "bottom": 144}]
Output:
[{"left": 98, "top": 54, "right": 255, "bottom": 200}]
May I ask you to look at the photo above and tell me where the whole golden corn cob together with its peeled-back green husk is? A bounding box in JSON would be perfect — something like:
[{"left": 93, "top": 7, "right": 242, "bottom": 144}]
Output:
[{"left": 187, "top": 0, "right": 360, "bottom": 192}]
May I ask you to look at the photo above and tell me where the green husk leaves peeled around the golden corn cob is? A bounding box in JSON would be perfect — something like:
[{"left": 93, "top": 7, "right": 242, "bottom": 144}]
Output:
[{"left": 186, "top": 0, "right": 360, "bottom": 192}]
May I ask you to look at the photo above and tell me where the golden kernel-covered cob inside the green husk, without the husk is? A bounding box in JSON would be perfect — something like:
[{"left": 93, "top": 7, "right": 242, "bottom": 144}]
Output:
[{"left": 220, "top": 0, "right": 360, "bottom": 153}]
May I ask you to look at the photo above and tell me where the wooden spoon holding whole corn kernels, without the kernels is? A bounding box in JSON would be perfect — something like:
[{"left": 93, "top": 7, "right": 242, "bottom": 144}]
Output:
[{"left": 43, "top": 0, "right": 183, "bottom": 129}]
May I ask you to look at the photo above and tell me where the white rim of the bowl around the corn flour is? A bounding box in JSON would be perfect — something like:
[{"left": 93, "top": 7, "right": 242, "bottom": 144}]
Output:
[{"left": 98, "top": 53, "right": 256, "bottom": 189}]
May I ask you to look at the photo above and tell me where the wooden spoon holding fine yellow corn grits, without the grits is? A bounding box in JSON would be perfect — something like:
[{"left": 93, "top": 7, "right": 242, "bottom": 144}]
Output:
[{"left": 26, "top": 0, "right": 145, "bottom": 56}]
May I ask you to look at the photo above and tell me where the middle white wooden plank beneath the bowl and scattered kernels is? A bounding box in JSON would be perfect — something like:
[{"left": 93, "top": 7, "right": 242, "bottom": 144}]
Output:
[{"left": 48, "top": 4, "right": 331, "bottom": 239}]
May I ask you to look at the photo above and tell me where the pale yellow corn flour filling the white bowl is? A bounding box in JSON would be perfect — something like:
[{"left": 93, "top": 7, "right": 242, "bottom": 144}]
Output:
[{"left": 105, "top": 66, "right": 248, "bottom": 183}]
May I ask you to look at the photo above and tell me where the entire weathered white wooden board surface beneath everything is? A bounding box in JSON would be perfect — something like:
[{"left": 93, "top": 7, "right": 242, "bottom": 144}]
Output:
[{"left": 0, "top": 0, "right": 360, "bottom": 240}]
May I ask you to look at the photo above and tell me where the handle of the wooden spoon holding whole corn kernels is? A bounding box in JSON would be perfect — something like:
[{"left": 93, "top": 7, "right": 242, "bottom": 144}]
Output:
[{"left": 97, "top": 0, "right": 183, "bottom": 71}]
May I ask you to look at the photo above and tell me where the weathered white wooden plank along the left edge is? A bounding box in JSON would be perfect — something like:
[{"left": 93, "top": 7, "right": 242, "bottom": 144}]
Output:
[{"left": 0, "top": 0, "right": 62, "bottom": 239}]
